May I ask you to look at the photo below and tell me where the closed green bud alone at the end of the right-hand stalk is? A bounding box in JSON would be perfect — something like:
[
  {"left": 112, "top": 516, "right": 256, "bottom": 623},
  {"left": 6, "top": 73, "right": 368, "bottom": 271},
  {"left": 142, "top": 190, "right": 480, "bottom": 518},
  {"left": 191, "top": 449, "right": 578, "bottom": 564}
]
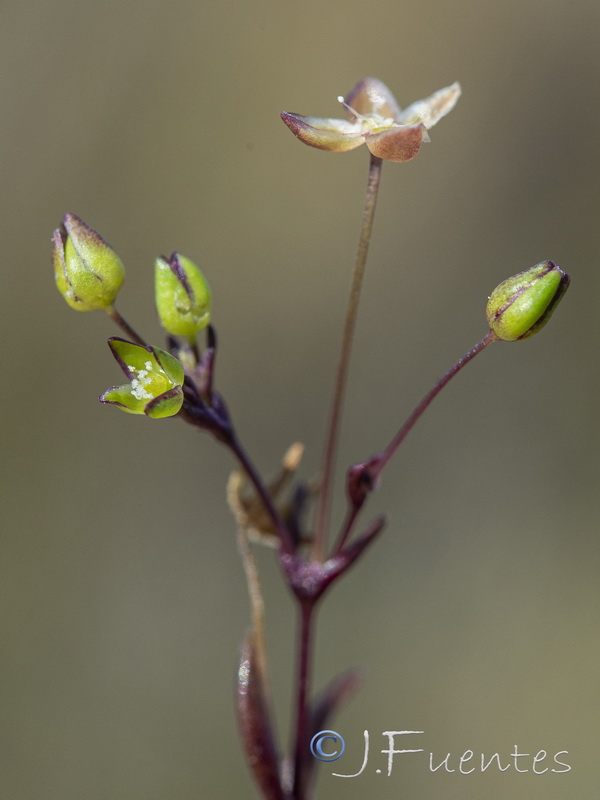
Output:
[{"left": 486, "top": 261, "right": 571, "bottom": 342}]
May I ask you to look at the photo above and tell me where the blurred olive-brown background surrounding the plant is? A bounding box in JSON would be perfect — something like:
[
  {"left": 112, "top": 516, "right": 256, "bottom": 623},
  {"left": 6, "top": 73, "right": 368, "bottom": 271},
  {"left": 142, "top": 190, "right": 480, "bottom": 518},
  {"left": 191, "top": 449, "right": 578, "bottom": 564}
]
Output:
[{"left": 0, "top": 0, "right": 600, "bottom": 800}]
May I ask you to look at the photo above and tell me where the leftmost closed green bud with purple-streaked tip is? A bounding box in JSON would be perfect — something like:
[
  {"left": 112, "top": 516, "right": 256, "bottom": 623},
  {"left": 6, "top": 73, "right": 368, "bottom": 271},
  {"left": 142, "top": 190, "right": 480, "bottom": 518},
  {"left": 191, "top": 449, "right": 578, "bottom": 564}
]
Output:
[{"left": 52, "top": 214, "right": 125, "bottom": 311}]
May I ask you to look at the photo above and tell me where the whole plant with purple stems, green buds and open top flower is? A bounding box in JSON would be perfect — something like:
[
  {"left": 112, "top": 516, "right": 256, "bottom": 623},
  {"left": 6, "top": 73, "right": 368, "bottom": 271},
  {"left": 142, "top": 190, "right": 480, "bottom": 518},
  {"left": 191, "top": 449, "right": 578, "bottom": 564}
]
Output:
[{"left": 52, "top": 78, "right": 570, "bottom": 800}]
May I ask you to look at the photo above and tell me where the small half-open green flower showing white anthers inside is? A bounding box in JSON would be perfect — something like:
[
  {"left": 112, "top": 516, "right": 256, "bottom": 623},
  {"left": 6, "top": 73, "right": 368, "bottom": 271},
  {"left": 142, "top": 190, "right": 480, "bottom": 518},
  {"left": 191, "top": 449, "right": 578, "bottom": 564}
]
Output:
[{"left": 99, "top": 336, "right": 184, "bottom": 419}]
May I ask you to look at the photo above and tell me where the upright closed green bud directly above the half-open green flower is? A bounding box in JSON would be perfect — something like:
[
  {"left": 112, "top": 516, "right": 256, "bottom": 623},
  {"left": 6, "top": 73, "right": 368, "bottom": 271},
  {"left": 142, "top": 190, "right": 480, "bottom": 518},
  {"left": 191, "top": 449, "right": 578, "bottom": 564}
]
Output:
[{"left": 154, "top": 253, "right": 211, "bottom": 343}]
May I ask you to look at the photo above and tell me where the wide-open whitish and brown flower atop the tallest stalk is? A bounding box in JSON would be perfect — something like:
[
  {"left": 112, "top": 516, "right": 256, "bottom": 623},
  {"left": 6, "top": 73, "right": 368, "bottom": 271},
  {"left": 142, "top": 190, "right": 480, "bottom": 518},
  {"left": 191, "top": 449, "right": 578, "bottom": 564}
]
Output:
[{"left": 281, "top": 78, "right": 461, "bottom": 161}]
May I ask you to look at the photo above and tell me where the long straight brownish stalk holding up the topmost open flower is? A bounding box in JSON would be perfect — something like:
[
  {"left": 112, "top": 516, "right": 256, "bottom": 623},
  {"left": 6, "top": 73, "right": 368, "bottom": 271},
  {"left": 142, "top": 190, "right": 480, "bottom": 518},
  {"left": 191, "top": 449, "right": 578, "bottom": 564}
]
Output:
[{"left": 313, "top": 155, "right": 382, "bottom": 561}]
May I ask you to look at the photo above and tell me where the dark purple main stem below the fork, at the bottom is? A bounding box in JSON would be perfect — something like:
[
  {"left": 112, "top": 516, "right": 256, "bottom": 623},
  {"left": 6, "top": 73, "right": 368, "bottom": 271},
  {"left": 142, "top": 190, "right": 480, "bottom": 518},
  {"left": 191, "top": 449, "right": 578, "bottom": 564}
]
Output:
[{"left": 292, "top": 599, "right": 316, "bottom": 800}]
